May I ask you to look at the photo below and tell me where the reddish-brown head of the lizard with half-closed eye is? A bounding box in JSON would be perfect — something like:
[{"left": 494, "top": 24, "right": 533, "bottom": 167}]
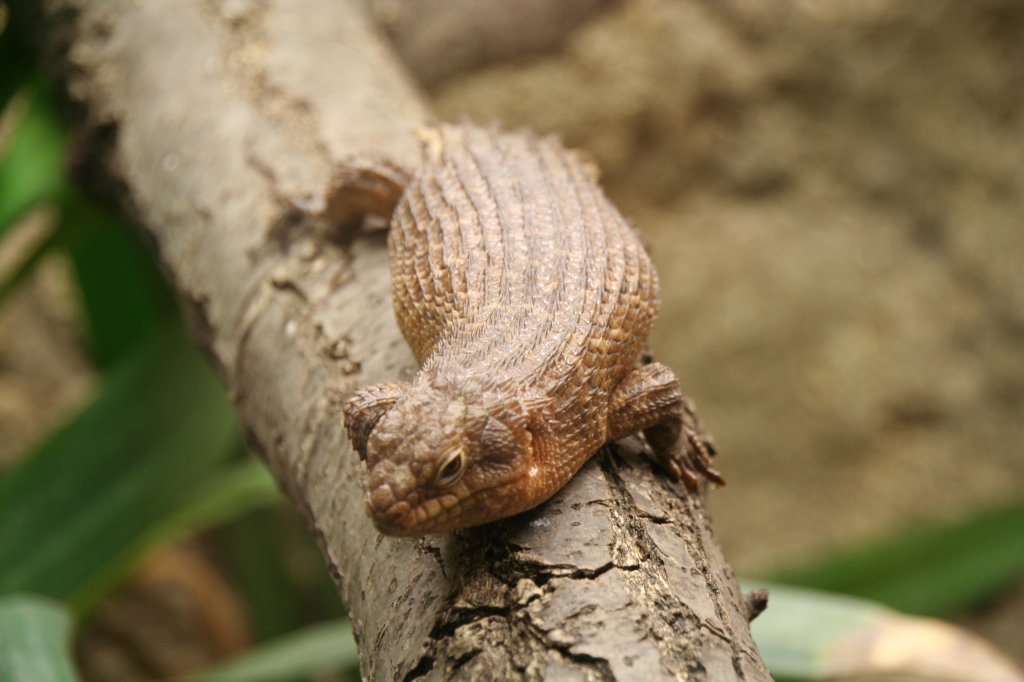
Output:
[{"left": 367, "top": 381, "right": 538, "bottom": 536}]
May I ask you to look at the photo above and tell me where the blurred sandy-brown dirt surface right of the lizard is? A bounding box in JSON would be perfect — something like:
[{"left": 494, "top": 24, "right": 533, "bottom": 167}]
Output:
[{"left": 432, "top": 0, "right": 1024, "bottom": 657}]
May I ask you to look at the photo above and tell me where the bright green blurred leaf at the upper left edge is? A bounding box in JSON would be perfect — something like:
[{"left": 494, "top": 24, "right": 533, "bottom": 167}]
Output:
[{"left": 0, "top": 77, "right": 67, "bottom": 238}]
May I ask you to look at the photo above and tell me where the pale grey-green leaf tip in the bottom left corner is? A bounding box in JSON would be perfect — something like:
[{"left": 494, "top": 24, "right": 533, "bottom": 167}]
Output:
[{"left": 0, "top": 594, "right": 78, "bottom": 682}]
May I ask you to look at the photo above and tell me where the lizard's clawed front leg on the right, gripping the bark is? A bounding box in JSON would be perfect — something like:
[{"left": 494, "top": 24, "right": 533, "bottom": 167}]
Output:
[{"left": 608, "top": 363, "right": 725, "bottom": 491}]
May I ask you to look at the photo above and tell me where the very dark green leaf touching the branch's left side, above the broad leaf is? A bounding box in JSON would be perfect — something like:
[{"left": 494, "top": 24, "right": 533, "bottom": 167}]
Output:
[{"left": 58, "top": 191, "right": 174, "bottom": 369}]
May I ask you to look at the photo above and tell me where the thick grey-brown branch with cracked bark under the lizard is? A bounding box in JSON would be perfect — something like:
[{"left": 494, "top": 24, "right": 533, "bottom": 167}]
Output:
[{"left": 16, "top": 0, "right": 768, "bottom": 680}]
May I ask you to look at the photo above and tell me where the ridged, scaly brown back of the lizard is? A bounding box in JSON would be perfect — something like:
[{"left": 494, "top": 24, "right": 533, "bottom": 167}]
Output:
[{"left": 389, "top": 127, "right": 658, "bottom": 417}]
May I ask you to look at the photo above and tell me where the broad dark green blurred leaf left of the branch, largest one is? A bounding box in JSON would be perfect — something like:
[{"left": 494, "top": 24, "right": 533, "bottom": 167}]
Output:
[{"left": 0, "top": 321, "right": 240, "bottom": 607}]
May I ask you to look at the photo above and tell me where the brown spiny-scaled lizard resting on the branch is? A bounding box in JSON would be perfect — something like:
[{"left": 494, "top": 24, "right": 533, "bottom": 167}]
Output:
[{"left": 338, "top": 124, "right": 724, "bottom": 537}]
